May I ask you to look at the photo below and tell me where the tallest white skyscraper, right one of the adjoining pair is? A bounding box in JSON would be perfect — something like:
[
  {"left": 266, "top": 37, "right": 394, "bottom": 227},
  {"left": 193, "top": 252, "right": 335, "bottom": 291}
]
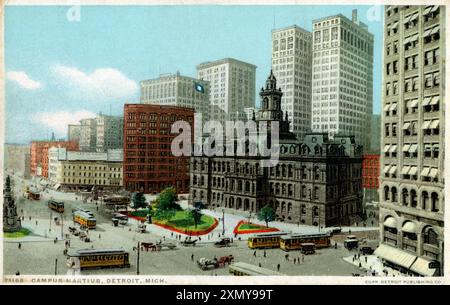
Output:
[{"left": 312, "top": 10, "right": 373, "bottom": 151}]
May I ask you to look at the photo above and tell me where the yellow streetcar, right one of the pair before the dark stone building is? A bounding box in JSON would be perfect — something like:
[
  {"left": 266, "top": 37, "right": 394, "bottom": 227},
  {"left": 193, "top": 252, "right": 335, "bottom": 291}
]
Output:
[{"left": 280, "top": 232, "right": 331, "bottom": 251}]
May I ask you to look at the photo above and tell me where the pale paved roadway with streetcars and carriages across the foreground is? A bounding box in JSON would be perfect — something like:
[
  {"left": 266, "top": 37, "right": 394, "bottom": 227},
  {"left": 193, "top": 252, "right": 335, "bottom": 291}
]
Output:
[{"left": 4, "top": 173, "right": 367, "bottom": 276}]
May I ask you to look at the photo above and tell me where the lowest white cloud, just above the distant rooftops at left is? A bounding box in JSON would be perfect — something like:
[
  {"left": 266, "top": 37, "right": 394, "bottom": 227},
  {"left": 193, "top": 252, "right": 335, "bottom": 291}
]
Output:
[{"left": 33, "top": 110, "right": 95, "bottom": 136}]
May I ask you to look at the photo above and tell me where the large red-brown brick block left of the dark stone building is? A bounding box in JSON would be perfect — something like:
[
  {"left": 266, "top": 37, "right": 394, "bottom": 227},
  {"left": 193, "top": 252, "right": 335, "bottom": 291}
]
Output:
[{"left": 123, "top": 104, "right": 194, "bottom": 194}]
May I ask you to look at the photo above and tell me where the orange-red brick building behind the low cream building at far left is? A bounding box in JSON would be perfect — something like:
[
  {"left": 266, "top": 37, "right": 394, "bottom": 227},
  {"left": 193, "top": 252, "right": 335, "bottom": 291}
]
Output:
[{"left": 30, "top": 141, "right": 78, "bottom": 177}]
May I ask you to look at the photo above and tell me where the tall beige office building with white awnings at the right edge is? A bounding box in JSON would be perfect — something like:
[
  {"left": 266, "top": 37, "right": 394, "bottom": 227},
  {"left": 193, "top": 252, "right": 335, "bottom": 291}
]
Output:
[{"left": 375, "top": 5, "right": 445, "bottom": 276}]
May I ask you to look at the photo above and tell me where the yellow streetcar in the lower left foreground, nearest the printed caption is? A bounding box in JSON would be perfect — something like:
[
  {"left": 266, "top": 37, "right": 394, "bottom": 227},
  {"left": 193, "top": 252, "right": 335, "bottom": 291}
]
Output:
[{"left": 67, "top": 249, "right": 130, "bottom": 270}]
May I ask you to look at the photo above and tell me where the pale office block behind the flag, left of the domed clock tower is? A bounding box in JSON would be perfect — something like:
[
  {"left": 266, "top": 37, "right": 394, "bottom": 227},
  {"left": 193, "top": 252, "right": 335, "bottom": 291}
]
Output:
[{"left": 197, "top": 58, "right": 256, "bottom": 123}]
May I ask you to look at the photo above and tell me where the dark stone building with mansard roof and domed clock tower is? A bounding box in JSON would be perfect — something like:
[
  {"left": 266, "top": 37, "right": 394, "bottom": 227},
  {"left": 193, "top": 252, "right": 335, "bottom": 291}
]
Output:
[{"left": 189, "top": 73, "right": 363, "bottom": 227}]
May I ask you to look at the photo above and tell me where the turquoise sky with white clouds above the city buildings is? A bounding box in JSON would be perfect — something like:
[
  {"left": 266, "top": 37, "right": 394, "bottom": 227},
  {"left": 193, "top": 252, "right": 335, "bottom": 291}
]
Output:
[{"left": 5, "top": 5, "right": 383, "bottom": 144}]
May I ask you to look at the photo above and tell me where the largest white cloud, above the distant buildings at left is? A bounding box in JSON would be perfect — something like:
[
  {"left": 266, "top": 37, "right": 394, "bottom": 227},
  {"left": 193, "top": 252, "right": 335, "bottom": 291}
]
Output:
[{"left": 51, "top": 65, "right": 138, "bottom": 102}]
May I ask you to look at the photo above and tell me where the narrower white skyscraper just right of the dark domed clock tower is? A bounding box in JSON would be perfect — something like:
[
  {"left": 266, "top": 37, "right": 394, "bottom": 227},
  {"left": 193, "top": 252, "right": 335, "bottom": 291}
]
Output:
[{"left": 272, "top": 25, "right": 312, "bottom": 140}]
